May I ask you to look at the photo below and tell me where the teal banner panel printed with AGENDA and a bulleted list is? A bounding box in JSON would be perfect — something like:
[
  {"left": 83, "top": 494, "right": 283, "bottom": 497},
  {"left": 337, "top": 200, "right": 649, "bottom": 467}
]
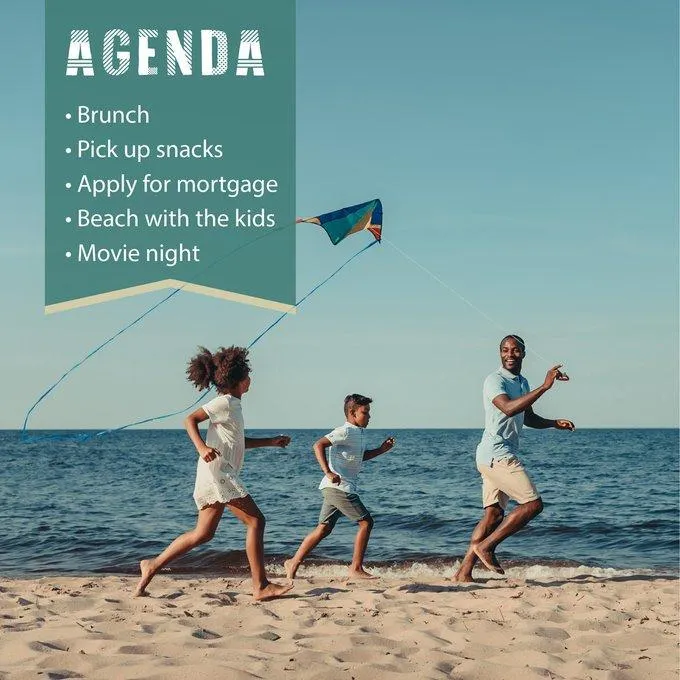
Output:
[{"left": 45, "top": 0, "right": 295, "bottom": 308}]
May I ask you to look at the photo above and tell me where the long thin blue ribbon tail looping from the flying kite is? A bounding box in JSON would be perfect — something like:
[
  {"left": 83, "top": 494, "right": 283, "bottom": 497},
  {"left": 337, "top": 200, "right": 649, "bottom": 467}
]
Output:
[{"left": 21, "top": 241, "right": 379, "bottom": 442}]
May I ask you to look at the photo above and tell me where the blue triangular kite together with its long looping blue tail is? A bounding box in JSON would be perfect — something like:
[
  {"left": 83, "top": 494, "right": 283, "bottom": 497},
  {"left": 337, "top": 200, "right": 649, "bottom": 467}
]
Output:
[{"left": 21, "top": 198, "right": 383, "bottom": 441}]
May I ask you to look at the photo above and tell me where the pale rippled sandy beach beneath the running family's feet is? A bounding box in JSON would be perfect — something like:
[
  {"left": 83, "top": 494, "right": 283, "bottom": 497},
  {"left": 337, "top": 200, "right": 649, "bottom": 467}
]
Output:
[{"left": 0, "top": 568, "right": 679, "bottom": 680}]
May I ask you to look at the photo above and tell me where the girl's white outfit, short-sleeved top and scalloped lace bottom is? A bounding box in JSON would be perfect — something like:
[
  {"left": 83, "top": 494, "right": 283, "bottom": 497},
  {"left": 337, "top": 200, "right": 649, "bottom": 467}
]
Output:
[{"left": 194, "top": 394, "right": 248, "bottom": 510}]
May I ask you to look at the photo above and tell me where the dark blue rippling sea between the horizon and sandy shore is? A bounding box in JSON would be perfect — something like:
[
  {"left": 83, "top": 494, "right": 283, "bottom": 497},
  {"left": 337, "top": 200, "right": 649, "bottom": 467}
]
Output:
[{"left": 0, "top": 428, "right": 680, "bottom": 576}]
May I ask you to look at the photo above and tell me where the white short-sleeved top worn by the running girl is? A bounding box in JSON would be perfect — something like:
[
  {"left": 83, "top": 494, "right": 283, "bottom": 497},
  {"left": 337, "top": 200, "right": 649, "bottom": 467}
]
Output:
[{"left": 202, "top": 394, "right": 246, "bottom": 474}]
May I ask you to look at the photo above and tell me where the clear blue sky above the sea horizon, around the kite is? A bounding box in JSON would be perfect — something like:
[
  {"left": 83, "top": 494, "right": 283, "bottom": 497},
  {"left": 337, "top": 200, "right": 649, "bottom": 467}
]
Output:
[{"left": 0, "top": 0, "right": 678, "bottom": 430}]
